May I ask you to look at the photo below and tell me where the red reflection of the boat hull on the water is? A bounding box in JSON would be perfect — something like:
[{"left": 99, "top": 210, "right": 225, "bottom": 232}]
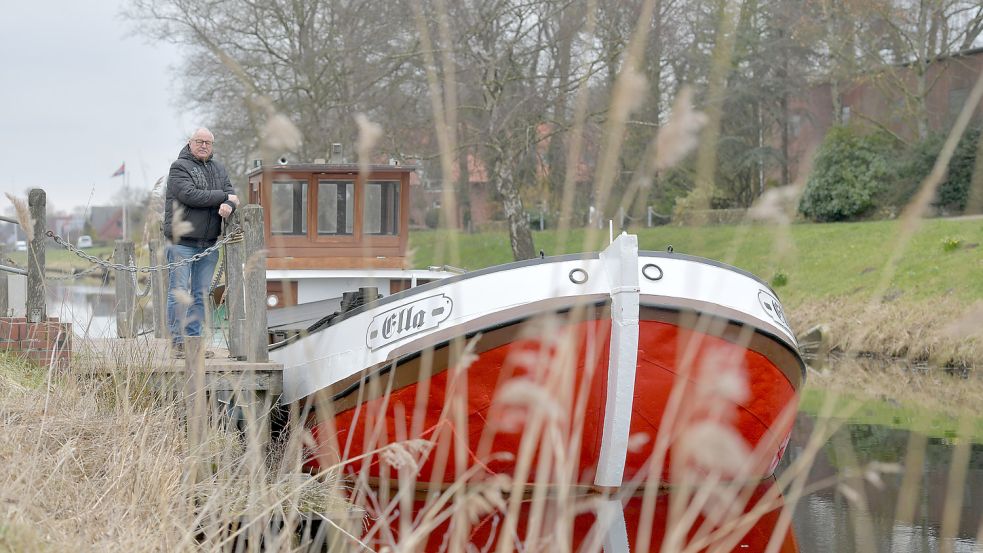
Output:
[{"left": 360, "top": 480, "right": 798, "bottom": 553}]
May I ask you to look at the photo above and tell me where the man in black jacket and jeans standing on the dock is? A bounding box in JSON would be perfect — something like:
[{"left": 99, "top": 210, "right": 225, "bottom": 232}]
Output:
[{"left": 164, "top": 128, "right": 239, "bottom": 357}]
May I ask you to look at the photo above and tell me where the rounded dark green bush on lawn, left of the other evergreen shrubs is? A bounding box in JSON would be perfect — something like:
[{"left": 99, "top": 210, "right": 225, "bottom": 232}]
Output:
[{"left": 799, "top": 126, "right": 896, "bottom": 221}]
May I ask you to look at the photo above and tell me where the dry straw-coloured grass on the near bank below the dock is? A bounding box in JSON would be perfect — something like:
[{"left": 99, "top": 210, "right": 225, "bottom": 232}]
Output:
[{"left": 0, "top": 339, "right": 349, "bottom": 551}]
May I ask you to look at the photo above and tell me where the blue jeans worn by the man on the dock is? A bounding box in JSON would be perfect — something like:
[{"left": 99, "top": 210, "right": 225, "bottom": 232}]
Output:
[{"left": 167, "top": 244, "right": 218, "bottom": 344}]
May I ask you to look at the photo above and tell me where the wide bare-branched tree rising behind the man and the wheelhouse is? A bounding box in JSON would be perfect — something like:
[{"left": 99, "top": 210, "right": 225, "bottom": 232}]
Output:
[{"left": 127, "top": 0, "right": 421, "bottom": 169}]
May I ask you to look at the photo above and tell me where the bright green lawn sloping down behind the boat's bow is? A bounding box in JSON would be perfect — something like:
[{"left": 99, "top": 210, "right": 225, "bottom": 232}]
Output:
[{"left": 410, "top": 219, "right": 983, "bottom": 307}]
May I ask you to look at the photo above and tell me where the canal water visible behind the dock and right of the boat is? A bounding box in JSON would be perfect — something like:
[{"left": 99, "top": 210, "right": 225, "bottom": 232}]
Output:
[{"left": 47, "top": 285, "right": 983, "bottom": 553}]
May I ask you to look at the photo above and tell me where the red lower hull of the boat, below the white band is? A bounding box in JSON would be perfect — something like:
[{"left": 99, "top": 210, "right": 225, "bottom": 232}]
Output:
[{"left": 310, "top": 317, "right": 798, "bottom": 486}]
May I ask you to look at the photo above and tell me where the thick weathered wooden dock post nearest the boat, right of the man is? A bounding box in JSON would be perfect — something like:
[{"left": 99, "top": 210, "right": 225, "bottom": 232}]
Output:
[{"left": 242, "top": 204, "right": 270, "bottom": 363}]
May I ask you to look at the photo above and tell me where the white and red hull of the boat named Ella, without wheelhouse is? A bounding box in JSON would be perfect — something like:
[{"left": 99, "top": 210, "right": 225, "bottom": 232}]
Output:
[{"left": 271, "top": 234, "right": 805, "bottom": 488}]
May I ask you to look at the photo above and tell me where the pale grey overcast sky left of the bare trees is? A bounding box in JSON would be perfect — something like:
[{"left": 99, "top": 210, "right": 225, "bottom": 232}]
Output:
[{"left": 0, "top": 0, "right": 195, "bottom": 212}]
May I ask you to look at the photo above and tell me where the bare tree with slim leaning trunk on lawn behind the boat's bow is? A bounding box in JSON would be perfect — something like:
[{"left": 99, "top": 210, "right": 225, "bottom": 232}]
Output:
[{"left": 422, "top": 0, "right": 616, "bottom": 259}]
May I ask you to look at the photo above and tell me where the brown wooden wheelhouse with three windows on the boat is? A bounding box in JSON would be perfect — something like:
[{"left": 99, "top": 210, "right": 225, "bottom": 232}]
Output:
[{"left": 247, "top": 163, "right": 446, "bottom": 307}]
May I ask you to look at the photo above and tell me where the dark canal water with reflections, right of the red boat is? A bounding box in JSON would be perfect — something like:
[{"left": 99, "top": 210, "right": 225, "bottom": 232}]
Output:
[{"left": 783, "top": 414, "right": 983, "bottom": 553}]
